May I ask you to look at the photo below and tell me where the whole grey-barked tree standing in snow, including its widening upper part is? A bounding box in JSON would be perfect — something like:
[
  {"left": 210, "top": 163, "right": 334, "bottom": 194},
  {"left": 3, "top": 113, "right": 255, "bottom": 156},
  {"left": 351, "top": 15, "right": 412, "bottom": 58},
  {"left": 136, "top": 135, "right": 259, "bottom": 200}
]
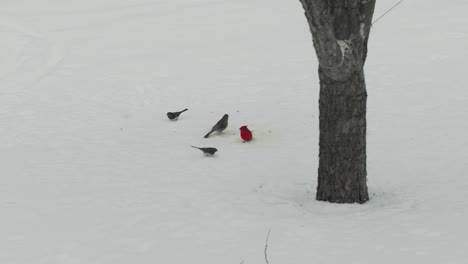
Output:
[{"left": 300, "top": 0, "right": 375, "bottom": 203}]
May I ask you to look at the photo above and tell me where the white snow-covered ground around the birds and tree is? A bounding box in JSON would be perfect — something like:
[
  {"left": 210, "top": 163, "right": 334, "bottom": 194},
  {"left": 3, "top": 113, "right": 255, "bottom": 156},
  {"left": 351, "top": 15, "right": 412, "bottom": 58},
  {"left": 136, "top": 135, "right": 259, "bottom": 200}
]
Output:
[{"left": 0, "top": 0, "right": 468, "bottom": 264}]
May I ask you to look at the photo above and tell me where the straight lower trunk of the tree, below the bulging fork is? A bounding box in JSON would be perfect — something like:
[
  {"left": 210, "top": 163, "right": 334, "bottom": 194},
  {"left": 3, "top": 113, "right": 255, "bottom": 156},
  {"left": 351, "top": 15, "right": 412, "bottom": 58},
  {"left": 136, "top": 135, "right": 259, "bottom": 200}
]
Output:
[{"left": 316, "top": 71, "right": 369, "bottom": 203}]
